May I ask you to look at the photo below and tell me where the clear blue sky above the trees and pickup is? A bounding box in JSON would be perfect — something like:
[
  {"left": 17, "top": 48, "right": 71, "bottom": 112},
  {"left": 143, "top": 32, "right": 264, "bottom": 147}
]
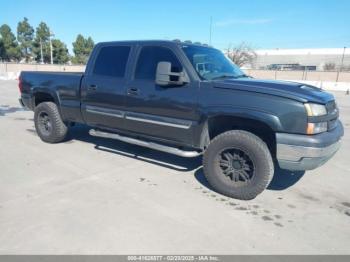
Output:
[{"left": 0, "top": 0, "right": 350, "bottom": 50}]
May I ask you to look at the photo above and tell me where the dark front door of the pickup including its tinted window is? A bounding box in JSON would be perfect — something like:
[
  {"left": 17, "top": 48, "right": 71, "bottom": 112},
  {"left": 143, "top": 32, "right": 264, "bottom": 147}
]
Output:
[{"left": 125, "top": 46, "right": 199, "bottom": 145}]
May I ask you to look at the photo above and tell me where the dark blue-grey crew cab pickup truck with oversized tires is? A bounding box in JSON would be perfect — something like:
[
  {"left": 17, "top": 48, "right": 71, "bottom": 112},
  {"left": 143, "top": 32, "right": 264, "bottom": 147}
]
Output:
[{"left": 19, "top": 41, "right": 344, "bottom": 200}]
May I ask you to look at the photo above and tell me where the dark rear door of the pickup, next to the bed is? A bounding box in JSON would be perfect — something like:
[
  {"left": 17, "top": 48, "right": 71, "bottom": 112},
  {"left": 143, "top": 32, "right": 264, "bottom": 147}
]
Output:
[{"left": 81, "top": 45, "right": 132, "bottom": 129}]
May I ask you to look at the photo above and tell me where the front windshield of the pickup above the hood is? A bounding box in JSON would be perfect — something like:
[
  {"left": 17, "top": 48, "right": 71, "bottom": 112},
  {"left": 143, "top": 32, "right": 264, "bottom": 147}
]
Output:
[{"left": 182, "top": 45, "right": 246, "bottom": 80}]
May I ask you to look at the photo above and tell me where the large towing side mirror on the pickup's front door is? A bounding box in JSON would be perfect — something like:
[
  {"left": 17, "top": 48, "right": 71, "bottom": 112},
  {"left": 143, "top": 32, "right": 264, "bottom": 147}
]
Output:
[{"left": 156, "top": 62, "right": 189, "bottom": 86}]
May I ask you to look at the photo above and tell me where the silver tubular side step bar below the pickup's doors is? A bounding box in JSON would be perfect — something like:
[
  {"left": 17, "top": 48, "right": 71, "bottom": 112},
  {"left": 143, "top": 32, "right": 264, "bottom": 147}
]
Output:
[{"left": 89, "top": 129, "right": 202, "bottom": 157}]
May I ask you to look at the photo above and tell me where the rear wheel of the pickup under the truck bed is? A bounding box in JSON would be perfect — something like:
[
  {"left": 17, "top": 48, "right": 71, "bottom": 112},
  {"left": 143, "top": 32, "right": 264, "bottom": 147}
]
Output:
[{"left": 34, "top": 102, "right": 68, "bottom": 143}]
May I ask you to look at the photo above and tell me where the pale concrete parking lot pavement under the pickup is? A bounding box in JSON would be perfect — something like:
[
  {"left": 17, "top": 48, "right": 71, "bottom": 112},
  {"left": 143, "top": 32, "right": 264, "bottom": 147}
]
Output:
[{"left": 0, "top": 81, "right": 350, "bottom": 254}]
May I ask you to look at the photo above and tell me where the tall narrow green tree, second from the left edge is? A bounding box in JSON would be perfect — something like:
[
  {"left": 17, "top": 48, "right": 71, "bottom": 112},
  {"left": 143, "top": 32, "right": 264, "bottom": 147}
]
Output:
[{"left": 17, "top": 17, "right": 34, "bottom": 62}]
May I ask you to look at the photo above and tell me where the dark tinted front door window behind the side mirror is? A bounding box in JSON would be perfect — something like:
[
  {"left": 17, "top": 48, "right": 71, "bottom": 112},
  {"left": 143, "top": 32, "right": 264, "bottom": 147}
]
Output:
[{"left": 135, "top": 46, "right": 182, "bottom": 80}]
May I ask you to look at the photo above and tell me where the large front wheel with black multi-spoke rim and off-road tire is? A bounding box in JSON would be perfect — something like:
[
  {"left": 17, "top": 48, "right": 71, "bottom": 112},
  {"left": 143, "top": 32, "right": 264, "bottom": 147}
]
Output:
[{"left": 203, "top": 130, "right": 274, "bottom": 200}]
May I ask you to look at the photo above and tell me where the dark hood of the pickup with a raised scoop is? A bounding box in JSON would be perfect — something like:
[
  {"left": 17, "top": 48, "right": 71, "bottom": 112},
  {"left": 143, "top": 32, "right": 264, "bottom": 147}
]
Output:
[{"left": 212, "top": 78, "right": 334, "bottom": 104}]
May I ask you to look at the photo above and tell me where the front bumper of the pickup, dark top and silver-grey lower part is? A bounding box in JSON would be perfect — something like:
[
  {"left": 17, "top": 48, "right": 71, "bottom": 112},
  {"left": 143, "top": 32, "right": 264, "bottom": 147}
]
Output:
[{"left": 276, "top": 121, "right": 344, "bottom": 171}]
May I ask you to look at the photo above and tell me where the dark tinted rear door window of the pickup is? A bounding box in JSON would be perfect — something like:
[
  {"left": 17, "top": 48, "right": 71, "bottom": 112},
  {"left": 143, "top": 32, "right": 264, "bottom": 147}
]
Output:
[{"left": 93, "top": 46, "right": 130, "bottom": 77}]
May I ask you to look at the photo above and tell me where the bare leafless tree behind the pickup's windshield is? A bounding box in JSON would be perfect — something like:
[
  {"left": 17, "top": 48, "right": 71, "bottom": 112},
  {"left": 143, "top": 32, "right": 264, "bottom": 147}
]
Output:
[{"left": 227, "top": 42, "right": 257, "bottom": 67}]
